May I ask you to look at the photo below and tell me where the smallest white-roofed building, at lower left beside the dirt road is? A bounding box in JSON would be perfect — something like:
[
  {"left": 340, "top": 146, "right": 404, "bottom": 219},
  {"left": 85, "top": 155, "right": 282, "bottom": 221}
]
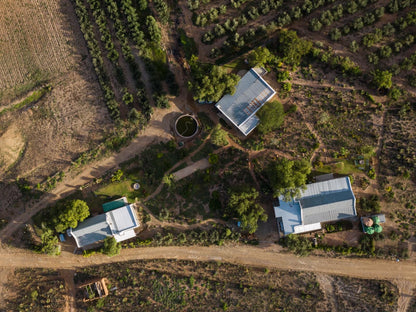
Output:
[{"left": 68, "top": 198, "right": 140, "bottom": 248}]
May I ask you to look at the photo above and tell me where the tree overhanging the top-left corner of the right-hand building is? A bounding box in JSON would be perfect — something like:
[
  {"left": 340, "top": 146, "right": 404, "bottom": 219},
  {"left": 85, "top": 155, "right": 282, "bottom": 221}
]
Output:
[{"left": 266, "top": 158, "right": 311, "bottom": 201}]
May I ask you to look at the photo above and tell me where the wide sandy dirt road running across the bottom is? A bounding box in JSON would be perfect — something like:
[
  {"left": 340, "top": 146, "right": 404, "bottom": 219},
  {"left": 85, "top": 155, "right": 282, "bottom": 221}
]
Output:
[{"left": 0, "top": 245, "right": 416, "bottom": 283}]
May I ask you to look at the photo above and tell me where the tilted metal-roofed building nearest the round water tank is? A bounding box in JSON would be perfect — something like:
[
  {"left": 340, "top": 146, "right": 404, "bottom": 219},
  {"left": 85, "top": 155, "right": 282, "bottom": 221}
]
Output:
[{"left": 215, "top": 68, "right": 276, "bottom": 136}]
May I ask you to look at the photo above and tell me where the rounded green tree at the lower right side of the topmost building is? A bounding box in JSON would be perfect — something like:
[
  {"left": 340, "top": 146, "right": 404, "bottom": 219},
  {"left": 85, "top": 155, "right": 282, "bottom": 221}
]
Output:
[{"left": 257, "top": 101, "right": 285, "bottom": 134}]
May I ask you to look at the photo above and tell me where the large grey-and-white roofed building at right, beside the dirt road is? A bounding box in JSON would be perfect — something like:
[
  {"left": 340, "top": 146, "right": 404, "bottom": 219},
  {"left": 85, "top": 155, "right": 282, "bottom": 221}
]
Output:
[{"left": 273, "top": 177, "right": 357, "bottom": 235}]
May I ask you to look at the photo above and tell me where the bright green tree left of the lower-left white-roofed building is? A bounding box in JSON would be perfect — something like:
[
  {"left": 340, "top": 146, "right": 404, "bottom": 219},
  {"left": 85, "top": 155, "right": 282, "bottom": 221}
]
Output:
[{"left": 53, "top": 199, "right": 90, "bottom": 233}]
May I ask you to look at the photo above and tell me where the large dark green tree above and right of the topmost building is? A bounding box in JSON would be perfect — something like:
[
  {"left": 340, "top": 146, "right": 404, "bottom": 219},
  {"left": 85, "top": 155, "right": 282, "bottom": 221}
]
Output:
[{"left": 273, "top": 30, "right": 312, "bottom": 66}]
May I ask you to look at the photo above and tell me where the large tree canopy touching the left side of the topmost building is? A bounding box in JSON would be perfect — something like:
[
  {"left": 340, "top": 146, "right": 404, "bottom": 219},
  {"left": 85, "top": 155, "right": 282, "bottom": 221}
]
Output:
[{"left": 189, "top": 56, "right": 240, "bottom": 102}]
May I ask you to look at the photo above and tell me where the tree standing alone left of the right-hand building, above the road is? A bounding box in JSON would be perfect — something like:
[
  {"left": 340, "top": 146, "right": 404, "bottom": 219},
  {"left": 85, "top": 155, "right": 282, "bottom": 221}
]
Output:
[{"left": 227, "top": 188, "right": 267, "bottom": 234}]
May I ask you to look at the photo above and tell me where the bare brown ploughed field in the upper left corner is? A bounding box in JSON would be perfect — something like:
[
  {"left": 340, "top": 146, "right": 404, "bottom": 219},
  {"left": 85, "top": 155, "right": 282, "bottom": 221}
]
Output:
[{"left": 0, "top": 0, "right": 111, "bottom": 183}]
